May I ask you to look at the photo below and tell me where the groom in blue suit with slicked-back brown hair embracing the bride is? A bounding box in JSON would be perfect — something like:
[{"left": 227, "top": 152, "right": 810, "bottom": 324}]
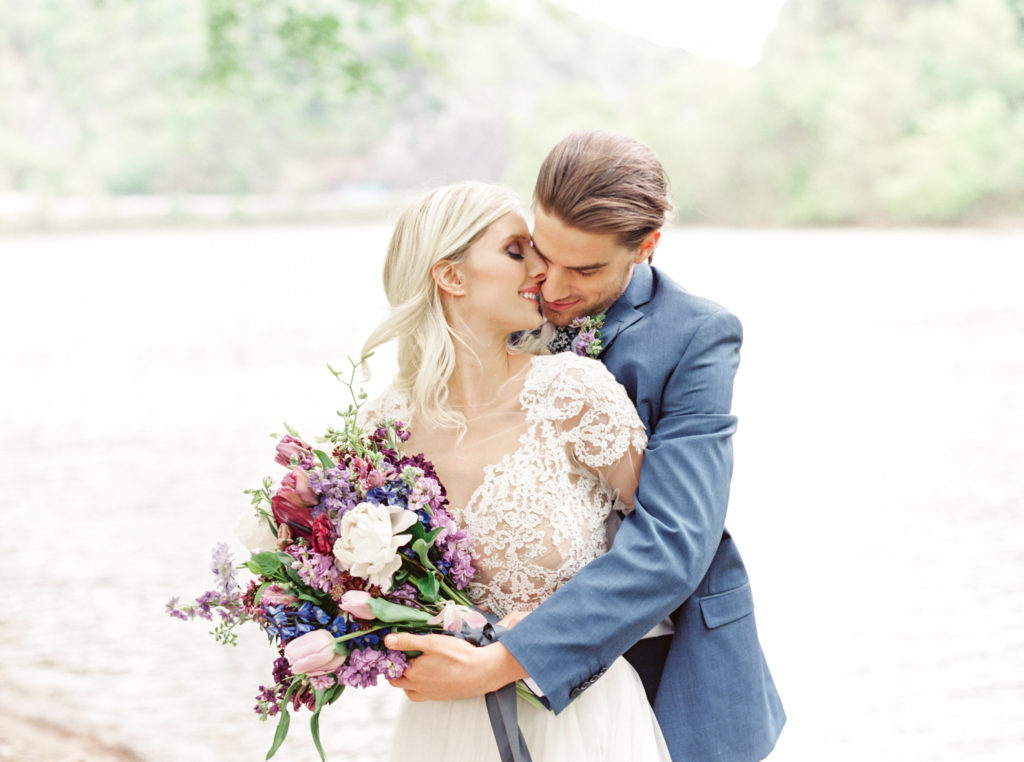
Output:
[{"left": 387, "top": 132, "right": 785, "bottom": 762}]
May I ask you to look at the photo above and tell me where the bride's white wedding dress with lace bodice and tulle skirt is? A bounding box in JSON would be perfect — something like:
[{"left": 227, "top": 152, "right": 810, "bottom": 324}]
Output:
[{"left": 371, "top": 352, "right": 669, "bottom": 762}]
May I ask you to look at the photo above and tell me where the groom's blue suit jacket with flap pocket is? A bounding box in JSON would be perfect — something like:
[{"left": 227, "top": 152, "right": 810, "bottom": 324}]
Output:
[{"left": 502, "top": 264, "right": 785, "bottom": 762}]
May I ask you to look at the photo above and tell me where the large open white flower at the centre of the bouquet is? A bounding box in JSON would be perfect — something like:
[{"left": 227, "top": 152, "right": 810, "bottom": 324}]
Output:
[{"left": 334, "top": 503, "right": 419, "bottom": 592}]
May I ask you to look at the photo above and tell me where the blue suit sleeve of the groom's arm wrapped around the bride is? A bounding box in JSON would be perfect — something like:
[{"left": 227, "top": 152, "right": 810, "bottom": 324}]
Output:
[{"left": 502, "top": 311, "right": 742, "bottom": 712}]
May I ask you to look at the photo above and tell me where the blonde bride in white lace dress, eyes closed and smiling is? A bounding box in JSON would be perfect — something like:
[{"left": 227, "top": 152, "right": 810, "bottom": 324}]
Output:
[{"left": 364, "top": 183, "right": 669, "bottom": 762}]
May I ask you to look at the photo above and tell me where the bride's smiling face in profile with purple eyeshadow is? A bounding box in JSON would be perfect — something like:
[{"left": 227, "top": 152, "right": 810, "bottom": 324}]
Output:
[{"left": 458, "top": 212, "right": 544, "bottom": 333}]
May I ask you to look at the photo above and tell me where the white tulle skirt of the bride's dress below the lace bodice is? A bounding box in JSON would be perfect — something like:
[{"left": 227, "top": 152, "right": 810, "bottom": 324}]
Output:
[{"left": 390, "top": 659, "right": 670, "bottom": 762}]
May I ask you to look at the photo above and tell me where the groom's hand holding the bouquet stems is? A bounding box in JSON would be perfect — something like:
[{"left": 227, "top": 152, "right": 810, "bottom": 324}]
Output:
[{"left": 384, "top": 633, "right": 527, "bottom": 702}]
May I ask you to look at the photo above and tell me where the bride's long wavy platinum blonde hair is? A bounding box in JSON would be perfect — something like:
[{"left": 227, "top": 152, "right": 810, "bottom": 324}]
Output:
[{"left": 362, "top": 182, "right": 536, "bottom": 428}]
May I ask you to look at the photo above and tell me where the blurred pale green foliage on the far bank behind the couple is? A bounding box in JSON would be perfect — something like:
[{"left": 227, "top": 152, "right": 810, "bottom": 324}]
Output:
[{"left": 0, "top": 0, "right": 1024, "bottom": 225}]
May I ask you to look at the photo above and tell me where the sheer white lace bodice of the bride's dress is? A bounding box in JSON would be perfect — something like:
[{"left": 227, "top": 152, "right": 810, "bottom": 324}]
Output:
[{"left": 370, "top": 352, "right": 647, "bottom": 616}]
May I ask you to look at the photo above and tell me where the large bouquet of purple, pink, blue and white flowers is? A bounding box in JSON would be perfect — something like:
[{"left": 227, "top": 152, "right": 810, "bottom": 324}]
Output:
[{"left": 167, "top": 361, "right": 485, "bottom": 760}]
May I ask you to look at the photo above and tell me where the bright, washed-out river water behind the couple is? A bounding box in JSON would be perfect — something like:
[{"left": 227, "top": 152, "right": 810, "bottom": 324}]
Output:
[{"left": 0, "top": 226, "right": 1024, "bottom": 762}]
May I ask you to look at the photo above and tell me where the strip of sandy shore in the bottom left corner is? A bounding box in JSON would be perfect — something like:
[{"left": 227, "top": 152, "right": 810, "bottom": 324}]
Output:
[{"left": 0, "top": 712, "right": 142, "bottom": 762}]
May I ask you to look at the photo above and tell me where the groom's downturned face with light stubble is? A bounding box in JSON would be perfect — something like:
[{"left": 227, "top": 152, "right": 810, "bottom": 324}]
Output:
[{"left": 534, "top": 206, "right": 656, "bottom": 326}]
